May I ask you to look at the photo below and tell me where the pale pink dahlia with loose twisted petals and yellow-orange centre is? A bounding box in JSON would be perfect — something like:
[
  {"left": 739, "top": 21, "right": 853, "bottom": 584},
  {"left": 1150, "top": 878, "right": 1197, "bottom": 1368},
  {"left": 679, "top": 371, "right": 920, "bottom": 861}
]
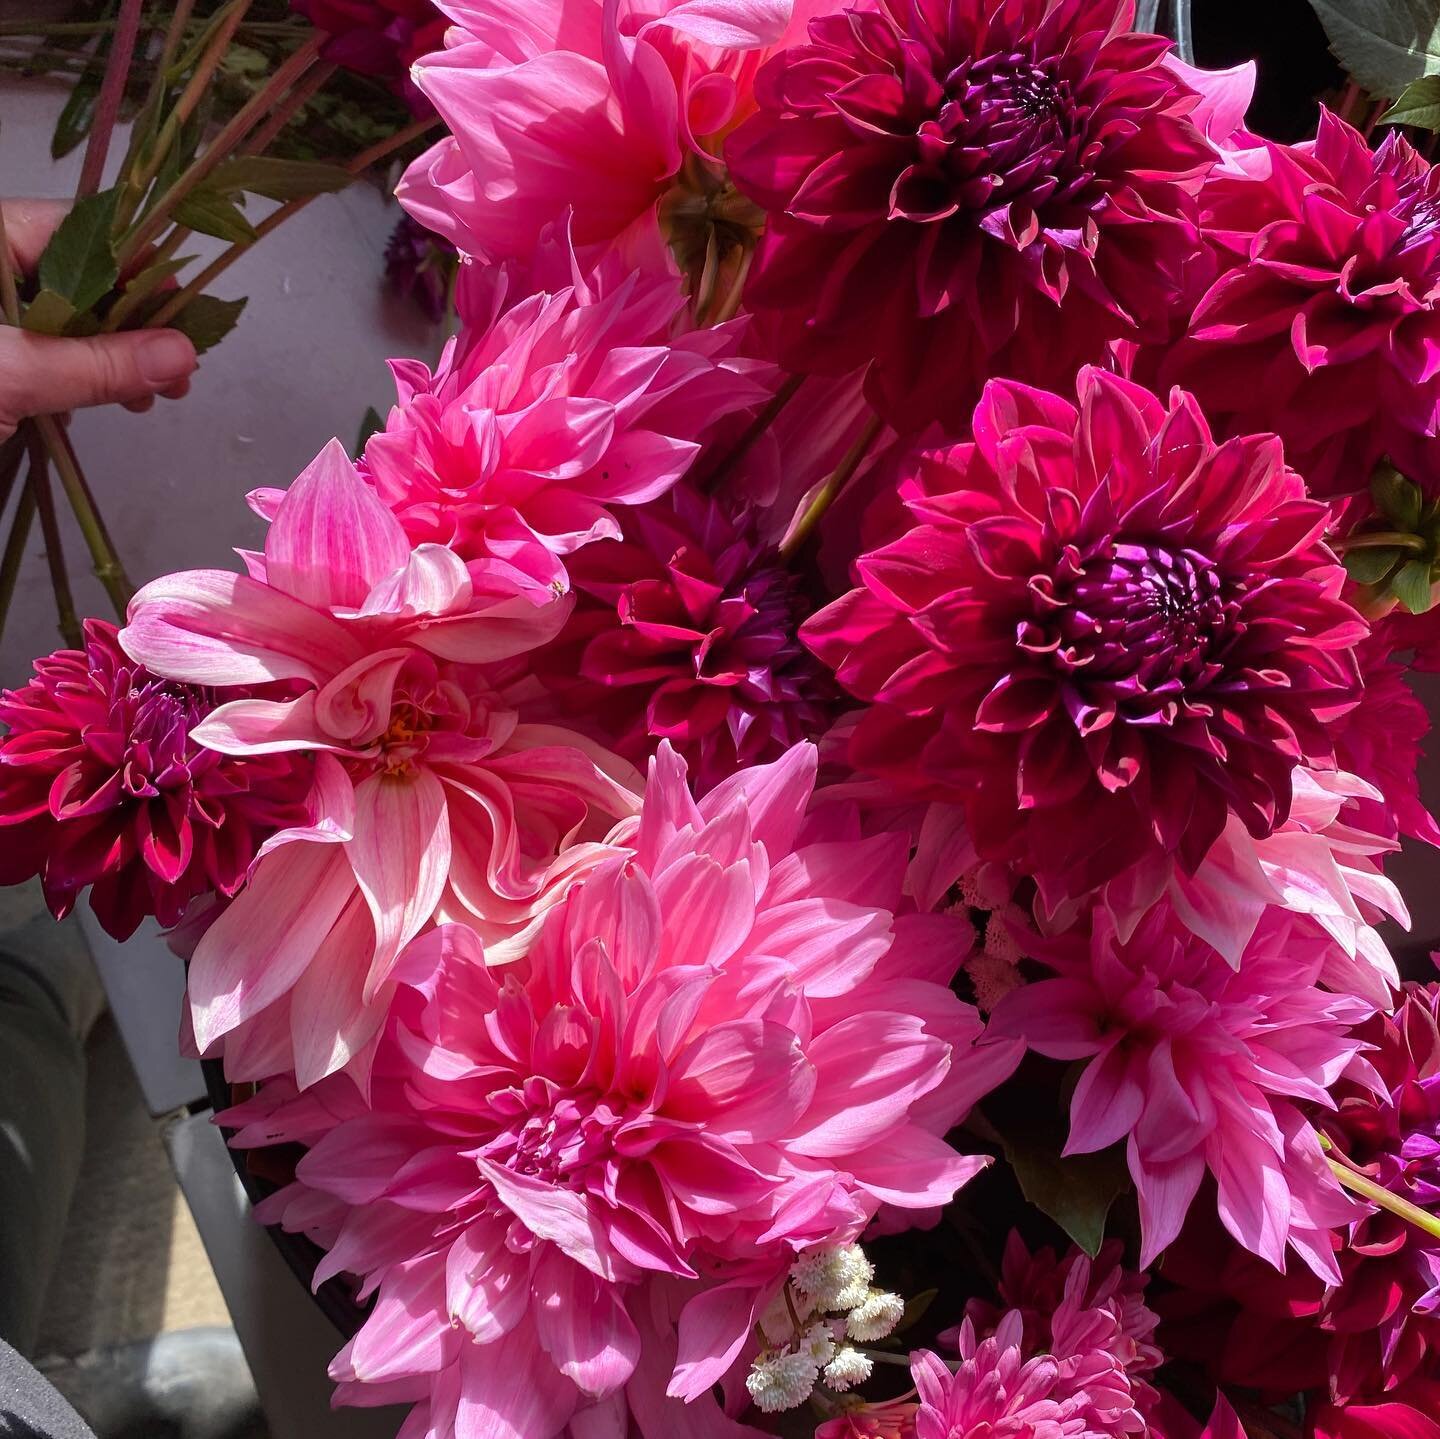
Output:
[{"left": 121, "top": 444, "right": 639, "bottom": 1085}]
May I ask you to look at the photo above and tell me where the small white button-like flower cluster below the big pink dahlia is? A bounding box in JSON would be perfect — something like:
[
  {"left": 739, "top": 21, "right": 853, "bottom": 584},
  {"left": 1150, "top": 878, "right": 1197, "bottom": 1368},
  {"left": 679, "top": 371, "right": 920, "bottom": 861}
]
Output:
[{"left": 744, "top": 1245, "right": 904, "bottom": 1415}]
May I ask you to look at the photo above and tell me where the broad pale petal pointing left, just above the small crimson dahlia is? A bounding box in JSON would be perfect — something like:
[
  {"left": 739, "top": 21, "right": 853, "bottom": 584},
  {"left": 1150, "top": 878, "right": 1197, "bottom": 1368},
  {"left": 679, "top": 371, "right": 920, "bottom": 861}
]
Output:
[{"left": 120, "top": 569, "right": 360, "bottom": 686}]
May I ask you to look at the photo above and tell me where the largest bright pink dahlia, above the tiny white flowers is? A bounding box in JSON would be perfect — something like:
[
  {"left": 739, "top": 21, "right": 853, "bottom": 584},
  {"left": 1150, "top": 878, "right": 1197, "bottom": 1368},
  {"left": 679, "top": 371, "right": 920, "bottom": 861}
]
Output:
[{"left": 226, "top": 745, "right": 1017, "bottom": 1439}]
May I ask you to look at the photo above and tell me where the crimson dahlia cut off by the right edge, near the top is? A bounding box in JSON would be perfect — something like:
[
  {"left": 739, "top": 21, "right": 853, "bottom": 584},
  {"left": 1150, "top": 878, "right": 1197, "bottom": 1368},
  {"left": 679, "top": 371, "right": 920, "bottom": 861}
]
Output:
[{"left": 1164, "top": 111, "right": 1440, "bottom": 496}]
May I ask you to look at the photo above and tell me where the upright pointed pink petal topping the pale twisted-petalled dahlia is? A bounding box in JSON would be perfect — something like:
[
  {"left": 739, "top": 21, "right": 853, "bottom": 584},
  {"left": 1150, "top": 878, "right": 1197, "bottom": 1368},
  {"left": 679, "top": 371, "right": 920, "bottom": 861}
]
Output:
[{"left": 265, "top": 439, "right": 410, "bottom": 609}]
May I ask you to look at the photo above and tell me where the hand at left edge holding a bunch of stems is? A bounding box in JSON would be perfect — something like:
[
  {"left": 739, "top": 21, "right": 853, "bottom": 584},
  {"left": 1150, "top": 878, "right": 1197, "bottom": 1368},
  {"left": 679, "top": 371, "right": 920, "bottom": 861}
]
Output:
[{"left": 0, "top": 200, "right": 196, "bottom": 441}]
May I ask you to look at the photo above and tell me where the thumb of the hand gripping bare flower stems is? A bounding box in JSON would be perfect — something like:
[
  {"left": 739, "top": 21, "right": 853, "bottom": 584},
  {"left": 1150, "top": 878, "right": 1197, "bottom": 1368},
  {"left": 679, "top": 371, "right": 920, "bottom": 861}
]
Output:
[{"left": 0, "top": 326, "right": 196, "bottom": 439}]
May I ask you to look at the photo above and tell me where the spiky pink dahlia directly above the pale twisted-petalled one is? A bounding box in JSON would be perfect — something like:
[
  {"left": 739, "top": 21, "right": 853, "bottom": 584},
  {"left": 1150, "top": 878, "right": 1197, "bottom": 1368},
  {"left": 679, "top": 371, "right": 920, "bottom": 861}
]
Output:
[{"left": 361, "top": 252, "right": 766, "bottom": 595}]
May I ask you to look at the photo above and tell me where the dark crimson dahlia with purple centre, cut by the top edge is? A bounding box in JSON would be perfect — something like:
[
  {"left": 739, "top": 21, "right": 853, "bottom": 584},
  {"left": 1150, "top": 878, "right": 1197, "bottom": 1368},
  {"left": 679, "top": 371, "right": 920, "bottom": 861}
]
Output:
[{"left": 727, "top": 0, "right": 1215, "bottom": 428}]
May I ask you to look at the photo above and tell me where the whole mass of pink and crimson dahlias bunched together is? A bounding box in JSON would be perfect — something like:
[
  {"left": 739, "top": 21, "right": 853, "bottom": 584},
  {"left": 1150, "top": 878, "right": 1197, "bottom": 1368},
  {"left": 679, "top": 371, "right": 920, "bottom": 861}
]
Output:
[{"left": 8, "top": 0, "right": 1440, "bottom": 1439}]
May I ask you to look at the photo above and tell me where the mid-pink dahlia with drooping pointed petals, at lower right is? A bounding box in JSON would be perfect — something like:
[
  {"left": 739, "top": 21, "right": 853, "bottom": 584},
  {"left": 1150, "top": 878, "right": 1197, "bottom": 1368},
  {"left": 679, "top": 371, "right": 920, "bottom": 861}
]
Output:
[{"left": 991, "top": 906, "right": 1372, "bottom": 1282}]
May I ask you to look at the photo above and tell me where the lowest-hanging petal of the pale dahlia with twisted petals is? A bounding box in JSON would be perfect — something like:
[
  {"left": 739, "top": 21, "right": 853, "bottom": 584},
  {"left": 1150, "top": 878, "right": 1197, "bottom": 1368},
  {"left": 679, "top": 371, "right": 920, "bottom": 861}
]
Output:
[{"left": 289, "top": 890, "right": 386, "bottom": 1089}]
